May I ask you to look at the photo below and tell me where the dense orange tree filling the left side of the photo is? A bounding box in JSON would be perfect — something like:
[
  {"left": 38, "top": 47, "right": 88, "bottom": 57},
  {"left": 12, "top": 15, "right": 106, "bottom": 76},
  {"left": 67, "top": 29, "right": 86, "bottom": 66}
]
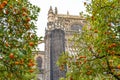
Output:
[{"left": 0, "top": 0, "right": 40, "bottom": 80}]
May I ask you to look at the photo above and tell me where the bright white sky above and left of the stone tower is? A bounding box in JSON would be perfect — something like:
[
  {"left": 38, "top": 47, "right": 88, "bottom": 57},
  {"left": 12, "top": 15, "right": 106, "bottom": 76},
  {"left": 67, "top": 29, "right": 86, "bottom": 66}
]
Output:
[{"left": 29, "top": 0, "right": 85, "bottom": 50}]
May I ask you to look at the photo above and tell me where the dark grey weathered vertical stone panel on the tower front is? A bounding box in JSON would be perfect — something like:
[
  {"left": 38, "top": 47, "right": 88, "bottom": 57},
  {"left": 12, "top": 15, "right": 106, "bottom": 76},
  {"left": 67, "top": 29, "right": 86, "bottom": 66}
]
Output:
[{"left": 50, "top": 29, "right": 65, "bottom": 80}]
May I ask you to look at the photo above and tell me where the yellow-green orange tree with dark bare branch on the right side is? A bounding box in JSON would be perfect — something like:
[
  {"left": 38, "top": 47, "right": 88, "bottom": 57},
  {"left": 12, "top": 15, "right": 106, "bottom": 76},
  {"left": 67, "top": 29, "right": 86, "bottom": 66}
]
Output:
[{"left": 57, "top": 0, "right": 120, "bottom": 80}]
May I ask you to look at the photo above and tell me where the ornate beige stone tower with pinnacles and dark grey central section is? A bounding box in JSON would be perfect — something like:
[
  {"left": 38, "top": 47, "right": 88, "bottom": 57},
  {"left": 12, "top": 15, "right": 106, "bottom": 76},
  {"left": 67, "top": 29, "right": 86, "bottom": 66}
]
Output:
[{"left": 44, "top": 7, "right": 86, "bottom": 80}]
